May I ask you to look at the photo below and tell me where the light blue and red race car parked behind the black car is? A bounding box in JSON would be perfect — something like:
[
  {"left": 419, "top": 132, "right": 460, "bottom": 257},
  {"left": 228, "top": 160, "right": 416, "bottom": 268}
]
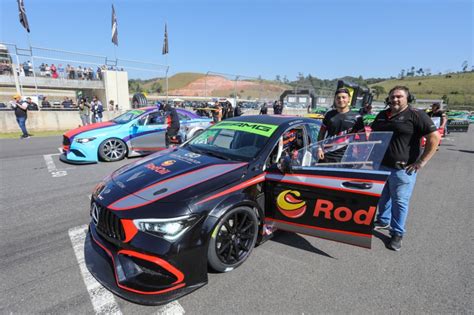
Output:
[{"left": 60, "top": 107, "right": 211, "bottom": 164}]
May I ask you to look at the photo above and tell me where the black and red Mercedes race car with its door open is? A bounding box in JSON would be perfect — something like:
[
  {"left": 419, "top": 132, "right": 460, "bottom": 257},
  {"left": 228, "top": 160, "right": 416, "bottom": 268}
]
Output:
[{"left": 85, "top": 115, "right": 391, "bottom": 304}]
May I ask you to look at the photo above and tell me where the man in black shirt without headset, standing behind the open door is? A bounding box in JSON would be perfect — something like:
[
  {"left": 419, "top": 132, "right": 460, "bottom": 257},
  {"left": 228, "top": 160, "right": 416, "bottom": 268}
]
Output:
[{"left": 318, "top": 88, "right": 364, "bottom": 163}]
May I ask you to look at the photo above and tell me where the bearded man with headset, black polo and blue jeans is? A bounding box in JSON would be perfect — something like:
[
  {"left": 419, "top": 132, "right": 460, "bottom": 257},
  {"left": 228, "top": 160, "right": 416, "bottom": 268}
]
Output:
[{"left": 372, "top": 86, "right": 440, "bottom": 251}]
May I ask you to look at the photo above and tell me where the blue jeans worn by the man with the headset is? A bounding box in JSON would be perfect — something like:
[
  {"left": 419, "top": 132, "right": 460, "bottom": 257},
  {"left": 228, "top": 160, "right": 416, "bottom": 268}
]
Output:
[{"left": 377, "top": 166, "right": 416, "bottom": 236}]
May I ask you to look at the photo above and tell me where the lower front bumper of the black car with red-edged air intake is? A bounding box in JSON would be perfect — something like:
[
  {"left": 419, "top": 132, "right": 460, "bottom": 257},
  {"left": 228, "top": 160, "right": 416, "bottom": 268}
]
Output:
[{"left": 85, "top": 224, "right": 207, "bottom": 305}]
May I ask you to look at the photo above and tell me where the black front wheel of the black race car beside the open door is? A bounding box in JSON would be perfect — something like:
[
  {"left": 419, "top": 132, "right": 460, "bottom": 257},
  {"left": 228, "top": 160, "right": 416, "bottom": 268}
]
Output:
[{"left": 207, "top": 207, "right": 259, "bottom": 272}]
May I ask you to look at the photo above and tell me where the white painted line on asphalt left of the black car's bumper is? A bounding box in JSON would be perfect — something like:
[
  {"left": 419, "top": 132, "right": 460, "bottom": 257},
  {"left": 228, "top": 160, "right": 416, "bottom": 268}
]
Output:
[{"left": 69, "top": 225, "right": 122, "bottom": 314}]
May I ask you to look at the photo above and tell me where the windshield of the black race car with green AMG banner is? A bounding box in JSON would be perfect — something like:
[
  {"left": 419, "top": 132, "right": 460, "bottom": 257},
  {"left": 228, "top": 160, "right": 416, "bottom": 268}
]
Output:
[{"left": 185, "top": 121, "right": 278, "bottom": 162}]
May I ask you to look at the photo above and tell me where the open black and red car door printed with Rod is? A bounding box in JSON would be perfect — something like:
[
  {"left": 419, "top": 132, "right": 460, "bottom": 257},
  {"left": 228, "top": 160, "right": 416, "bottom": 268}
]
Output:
[{"left": 265, "top": 132, "right": 392, "bottom": 248}]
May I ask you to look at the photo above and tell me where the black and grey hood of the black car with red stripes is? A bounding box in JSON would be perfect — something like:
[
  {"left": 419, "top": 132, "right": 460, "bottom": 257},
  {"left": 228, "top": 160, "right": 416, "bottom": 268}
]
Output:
[{"left": 108, "top": 148, "right": 247, "bottom": 210}]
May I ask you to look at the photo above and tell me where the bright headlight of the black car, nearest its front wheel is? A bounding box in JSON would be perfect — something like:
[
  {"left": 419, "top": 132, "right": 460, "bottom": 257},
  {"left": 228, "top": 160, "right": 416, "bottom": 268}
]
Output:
[{"left": 133, "top": 216, "right": 197, "bottom": 241}]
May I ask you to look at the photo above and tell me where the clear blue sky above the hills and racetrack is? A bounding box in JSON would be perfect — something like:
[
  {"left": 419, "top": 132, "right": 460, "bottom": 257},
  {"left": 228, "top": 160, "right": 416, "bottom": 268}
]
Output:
[{"left": 0, "top": 0, "right": 474, "bottom": 80}]
